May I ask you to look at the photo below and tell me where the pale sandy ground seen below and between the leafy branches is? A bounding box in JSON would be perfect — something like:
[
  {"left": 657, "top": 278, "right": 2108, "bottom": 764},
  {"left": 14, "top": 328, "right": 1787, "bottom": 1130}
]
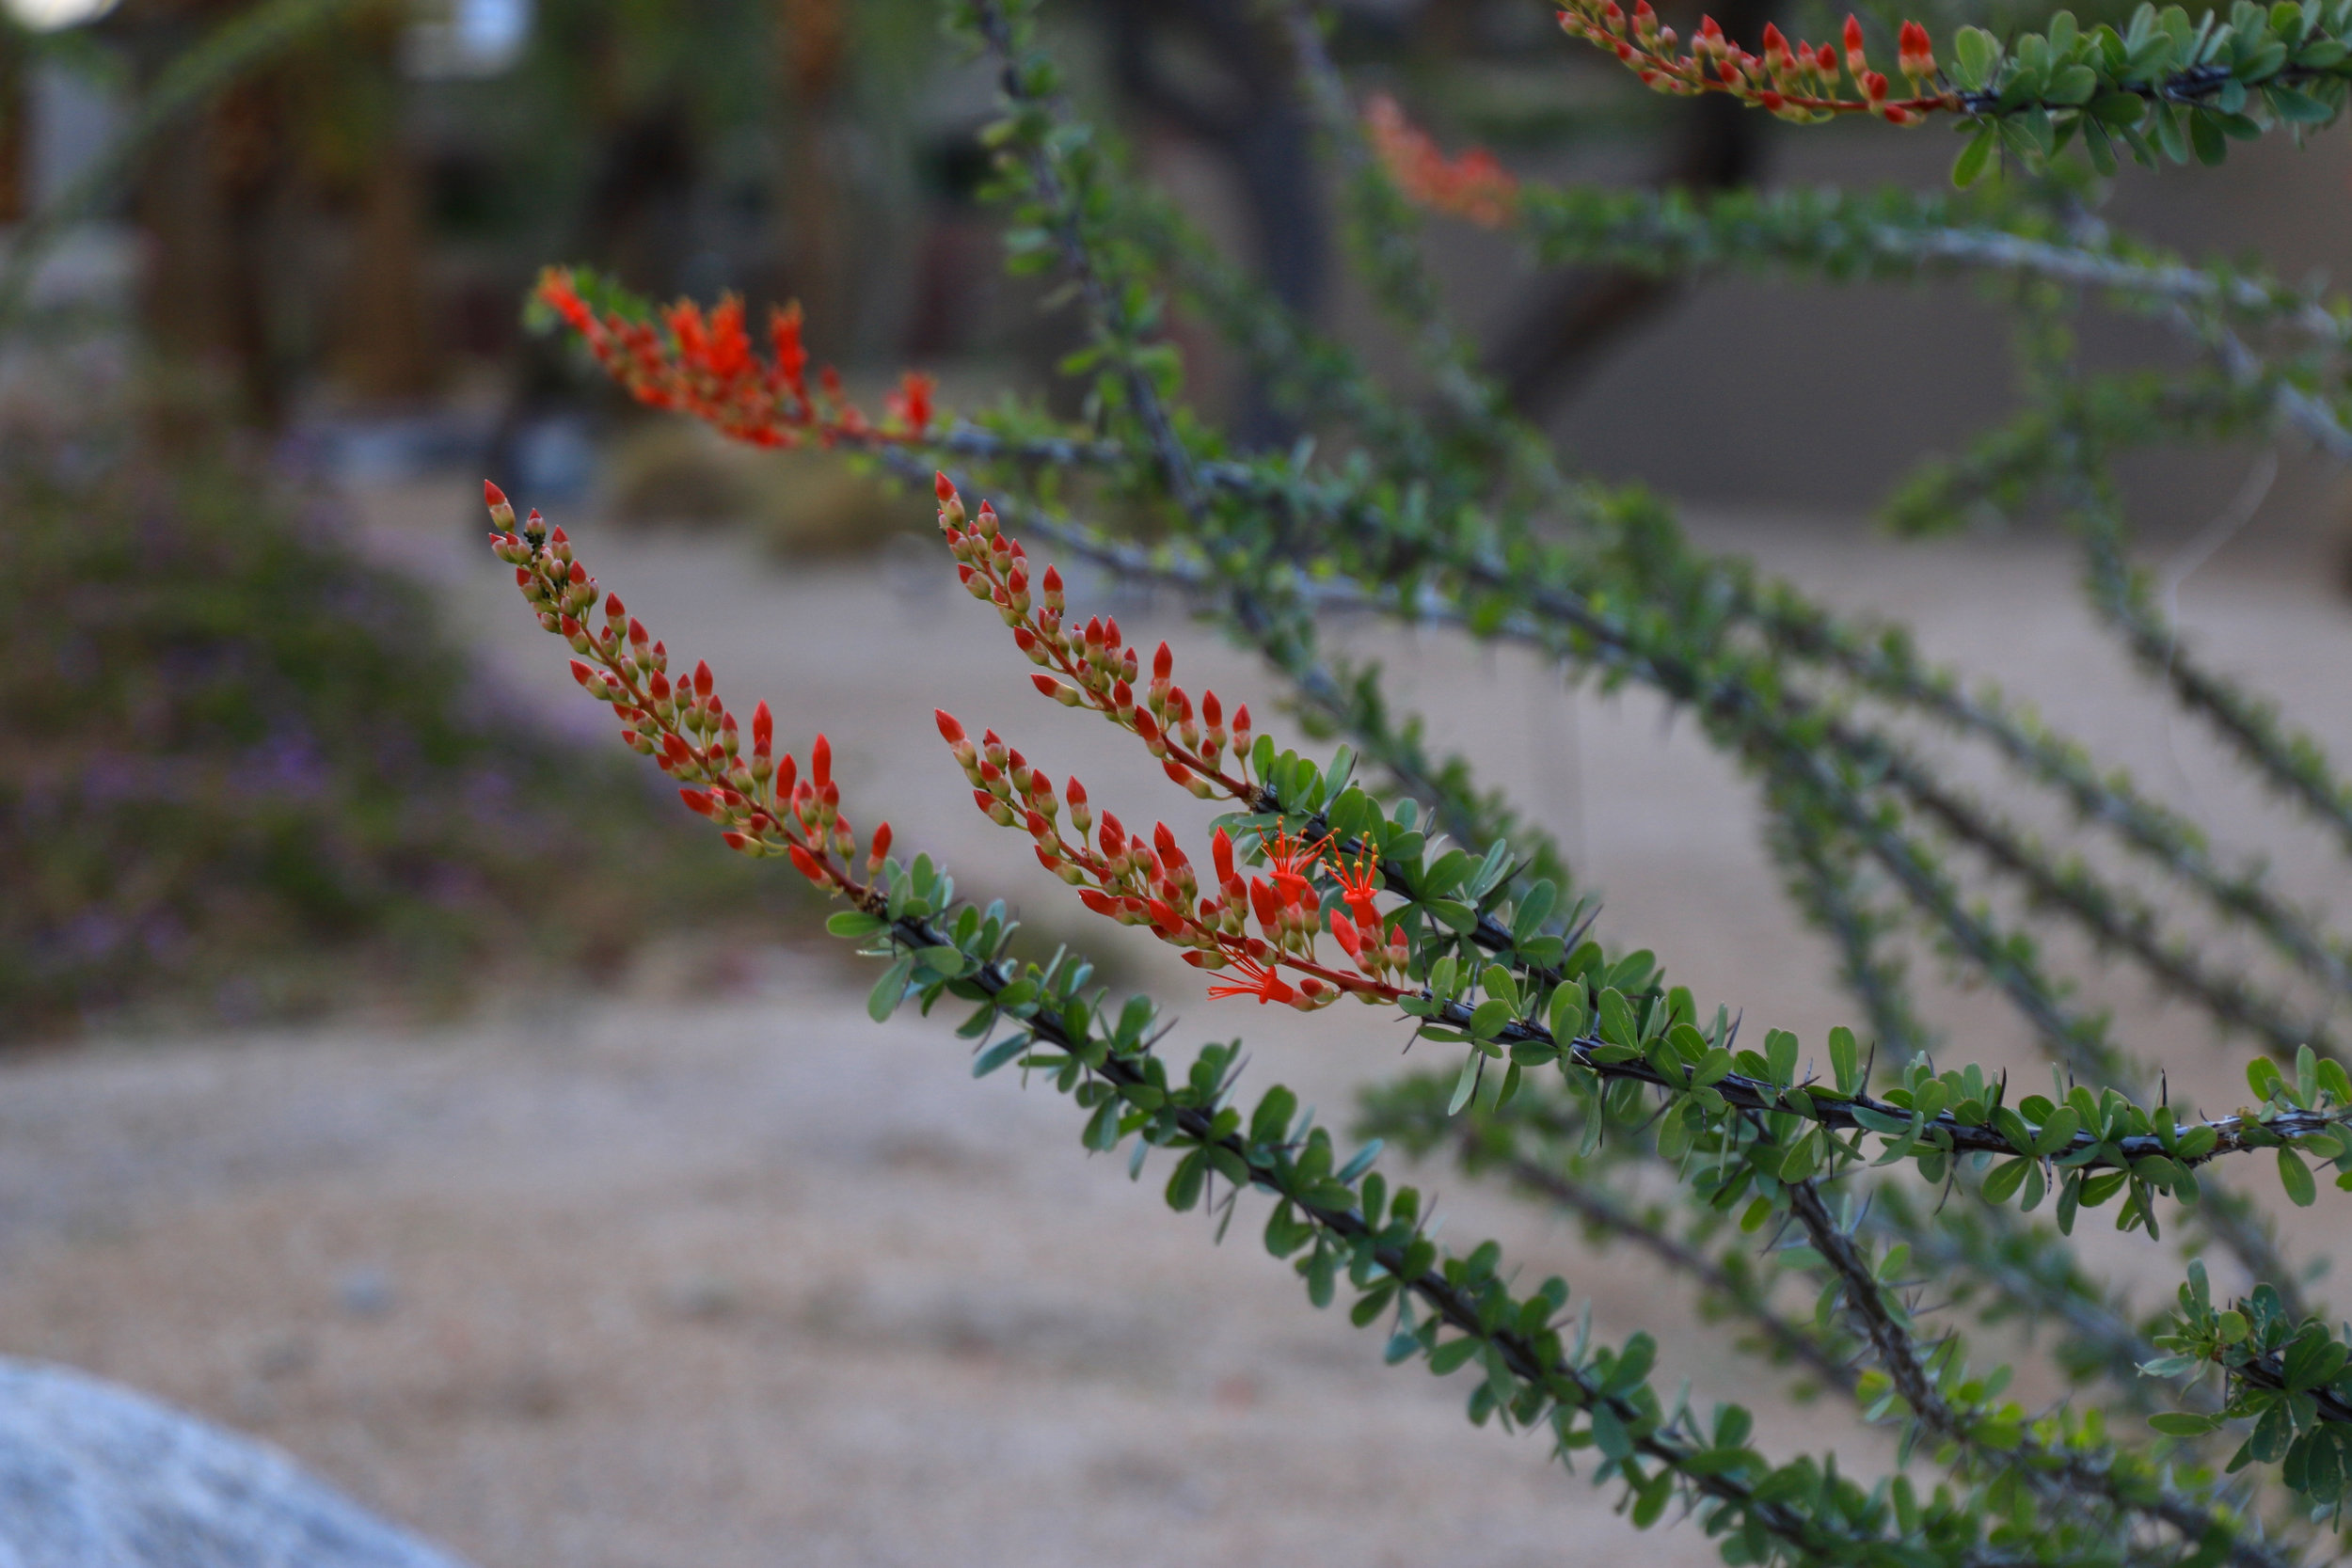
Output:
[{"left": 13, "top": 482, "right": 2352, "bottom": 1568}]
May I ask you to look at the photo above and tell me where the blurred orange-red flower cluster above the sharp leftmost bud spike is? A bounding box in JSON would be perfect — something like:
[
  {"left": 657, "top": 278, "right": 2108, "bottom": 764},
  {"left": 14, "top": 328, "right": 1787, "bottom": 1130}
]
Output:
[{"left": 539, "top": 268, "right": 934, "bottom": 447}]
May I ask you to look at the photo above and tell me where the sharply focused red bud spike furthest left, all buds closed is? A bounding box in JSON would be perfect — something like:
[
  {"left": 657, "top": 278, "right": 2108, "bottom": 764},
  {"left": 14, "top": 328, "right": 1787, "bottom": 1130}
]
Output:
[{"left": 483, "top": 480, "right": 889, "bottom": 903}]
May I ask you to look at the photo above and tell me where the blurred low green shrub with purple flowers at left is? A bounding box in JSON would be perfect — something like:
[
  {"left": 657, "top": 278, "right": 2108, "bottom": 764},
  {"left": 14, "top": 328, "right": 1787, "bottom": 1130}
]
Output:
[{"left": 0, "top": 389, "right": 774, "bottom": 1041}]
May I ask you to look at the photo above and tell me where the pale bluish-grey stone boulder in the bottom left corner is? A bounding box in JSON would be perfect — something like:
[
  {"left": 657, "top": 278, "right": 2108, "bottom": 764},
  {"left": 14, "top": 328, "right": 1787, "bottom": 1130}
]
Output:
[{"left": 0, "top": 1359, "right": 464, "bottom": 1568}]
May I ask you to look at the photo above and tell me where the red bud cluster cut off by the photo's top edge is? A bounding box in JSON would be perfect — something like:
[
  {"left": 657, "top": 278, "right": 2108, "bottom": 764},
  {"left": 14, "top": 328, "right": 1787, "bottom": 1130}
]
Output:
[{"left": 1560, "top": 0, "right": 1962, "bottom": 124}]
